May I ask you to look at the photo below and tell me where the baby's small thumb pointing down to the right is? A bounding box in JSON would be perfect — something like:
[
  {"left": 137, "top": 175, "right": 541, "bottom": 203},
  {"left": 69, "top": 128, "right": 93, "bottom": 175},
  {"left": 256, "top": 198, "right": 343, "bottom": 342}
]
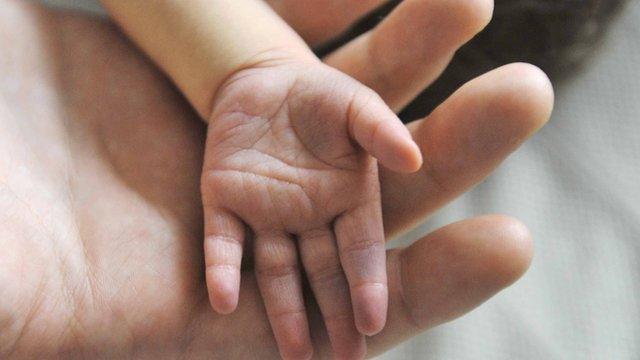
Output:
[{"left": 348, "top": 90, "right": 422, "bottom": 173}]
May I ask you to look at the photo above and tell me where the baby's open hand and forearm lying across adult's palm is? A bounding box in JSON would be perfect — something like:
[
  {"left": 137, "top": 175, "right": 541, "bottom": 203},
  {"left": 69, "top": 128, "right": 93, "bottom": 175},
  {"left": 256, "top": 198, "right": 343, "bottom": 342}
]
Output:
[{"left": 103, "top": 0, "right": 422, "bottom": 358}]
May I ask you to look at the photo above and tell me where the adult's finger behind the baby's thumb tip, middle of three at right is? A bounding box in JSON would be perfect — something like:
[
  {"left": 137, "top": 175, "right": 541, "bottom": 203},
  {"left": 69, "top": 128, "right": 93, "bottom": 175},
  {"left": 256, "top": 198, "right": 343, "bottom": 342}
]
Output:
[{"left": 380, "top": 63, "right": 553, "bottom": 235}]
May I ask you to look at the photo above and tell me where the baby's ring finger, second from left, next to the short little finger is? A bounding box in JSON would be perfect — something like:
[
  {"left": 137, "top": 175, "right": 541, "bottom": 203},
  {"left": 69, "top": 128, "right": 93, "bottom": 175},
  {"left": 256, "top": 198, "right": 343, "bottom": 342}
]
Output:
[{"left": 254, "top": 233, "right": 313, "bottom": 359}]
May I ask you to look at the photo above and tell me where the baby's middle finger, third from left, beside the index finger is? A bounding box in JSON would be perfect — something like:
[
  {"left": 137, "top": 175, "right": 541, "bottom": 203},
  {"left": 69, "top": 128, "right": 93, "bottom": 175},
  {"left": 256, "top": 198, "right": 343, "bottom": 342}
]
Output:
[{"left": 298, "top": 228, "right": 366, "bottom": 359}]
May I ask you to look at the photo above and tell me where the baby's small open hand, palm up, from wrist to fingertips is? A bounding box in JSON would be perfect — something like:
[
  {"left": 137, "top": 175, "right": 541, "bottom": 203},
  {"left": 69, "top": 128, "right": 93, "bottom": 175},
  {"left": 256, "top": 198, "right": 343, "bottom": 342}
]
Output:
[{"left": 202, "top": 62, "right": 422, "bottom": 358}]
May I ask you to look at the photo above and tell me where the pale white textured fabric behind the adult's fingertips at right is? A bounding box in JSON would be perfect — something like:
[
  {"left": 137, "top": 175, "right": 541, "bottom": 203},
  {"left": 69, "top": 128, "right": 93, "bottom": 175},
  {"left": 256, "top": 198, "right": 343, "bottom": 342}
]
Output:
[{"left": 38, "top": 0, "right": 640, "bottom": 360}]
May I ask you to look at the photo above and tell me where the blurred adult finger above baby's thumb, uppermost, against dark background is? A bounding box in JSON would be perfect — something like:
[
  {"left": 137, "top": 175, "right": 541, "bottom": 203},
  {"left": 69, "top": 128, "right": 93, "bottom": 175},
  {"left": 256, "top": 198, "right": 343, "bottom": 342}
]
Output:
[{"left": 325, "top": 0, "right": 493, "bottom": 111}]
